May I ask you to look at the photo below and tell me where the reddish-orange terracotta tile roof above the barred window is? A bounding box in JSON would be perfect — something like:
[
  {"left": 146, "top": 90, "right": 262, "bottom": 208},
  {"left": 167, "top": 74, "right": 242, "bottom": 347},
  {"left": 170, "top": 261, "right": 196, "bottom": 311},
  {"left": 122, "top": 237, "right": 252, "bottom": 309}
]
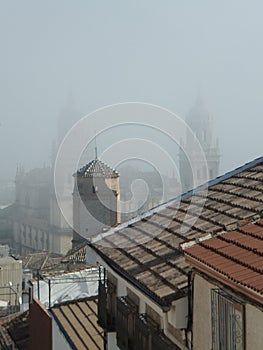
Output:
[{"left": 185, "top": 220, "right": 263, "bottom": 304}]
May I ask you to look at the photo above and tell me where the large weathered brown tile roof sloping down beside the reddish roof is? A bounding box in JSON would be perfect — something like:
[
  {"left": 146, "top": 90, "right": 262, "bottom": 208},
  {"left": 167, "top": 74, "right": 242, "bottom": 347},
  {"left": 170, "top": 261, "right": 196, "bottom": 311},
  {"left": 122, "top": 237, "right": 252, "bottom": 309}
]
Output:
[{"left": 90, "top": 157, "right": 263, "bottom": 306}]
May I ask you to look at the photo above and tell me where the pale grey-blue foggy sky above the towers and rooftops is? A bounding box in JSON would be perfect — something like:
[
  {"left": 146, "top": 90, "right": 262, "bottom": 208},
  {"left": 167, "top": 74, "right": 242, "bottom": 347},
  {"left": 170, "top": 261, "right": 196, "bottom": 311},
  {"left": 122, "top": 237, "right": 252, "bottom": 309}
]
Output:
[{"left": 0, "top": 0, "right": 263, "bottom": 183}]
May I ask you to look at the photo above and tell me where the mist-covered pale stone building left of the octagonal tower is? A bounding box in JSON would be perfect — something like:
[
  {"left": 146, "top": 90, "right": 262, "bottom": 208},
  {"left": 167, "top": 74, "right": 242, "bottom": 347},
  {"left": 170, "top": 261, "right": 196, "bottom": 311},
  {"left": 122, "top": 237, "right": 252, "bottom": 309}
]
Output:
[{"left": 11, "top": 167, "right": 72, "bottom": 255}]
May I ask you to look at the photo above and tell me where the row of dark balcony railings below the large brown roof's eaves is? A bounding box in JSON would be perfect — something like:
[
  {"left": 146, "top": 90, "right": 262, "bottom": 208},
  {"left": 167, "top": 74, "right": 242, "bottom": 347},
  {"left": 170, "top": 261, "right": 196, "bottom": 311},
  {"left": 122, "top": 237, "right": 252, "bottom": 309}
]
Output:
[{"left": 98, "top": 281, "right": 178, "bottom": 350}]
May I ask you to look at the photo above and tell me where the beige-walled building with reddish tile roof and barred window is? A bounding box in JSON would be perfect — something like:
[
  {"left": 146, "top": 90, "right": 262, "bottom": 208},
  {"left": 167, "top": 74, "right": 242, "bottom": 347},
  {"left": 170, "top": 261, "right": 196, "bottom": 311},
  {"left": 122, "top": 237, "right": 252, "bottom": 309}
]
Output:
[{"left": 185, "top": 220, "right": 263, "bottom": 350}]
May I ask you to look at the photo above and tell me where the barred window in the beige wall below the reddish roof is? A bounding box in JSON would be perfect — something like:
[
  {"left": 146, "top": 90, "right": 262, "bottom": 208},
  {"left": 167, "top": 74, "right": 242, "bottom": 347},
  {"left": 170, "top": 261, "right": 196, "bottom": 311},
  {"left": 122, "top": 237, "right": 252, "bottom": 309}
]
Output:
[{"left": 211, "top": 289, "right": 244, "bottom": 350}]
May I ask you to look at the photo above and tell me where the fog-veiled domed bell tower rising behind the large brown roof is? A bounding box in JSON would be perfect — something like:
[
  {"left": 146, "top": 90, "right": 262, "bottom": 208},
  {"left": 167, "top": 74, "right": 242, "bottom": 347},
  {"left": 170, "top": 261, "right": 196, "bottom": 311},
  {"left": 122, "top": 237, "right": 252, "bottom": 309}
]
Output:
[{"left": 179, "top": 97, "right": 220, "bottom": 193}]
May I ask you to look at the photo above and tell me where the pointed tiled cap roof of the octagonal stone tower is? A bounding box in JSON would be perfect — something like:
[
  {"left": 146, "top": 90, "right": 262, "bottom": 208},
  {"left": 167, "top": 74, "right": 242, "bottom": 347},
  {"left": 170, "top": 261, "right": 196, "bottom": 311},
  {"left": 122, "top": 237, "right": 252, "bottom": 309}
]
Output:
[{"left": 77, "top": 159, "right": 120, "bottom": 178}]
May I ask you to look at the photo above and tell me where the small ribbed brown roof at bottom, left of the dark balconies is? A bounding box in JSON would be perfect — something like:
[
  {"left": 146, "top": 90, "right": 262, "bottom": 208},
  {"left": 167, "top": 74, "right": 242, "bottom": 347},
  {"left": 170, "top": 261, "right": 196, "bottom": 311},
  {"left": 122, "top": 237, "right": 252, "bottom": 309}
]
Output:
[{"left": 50, "top": 298, "right": 104, "bottom": 350}]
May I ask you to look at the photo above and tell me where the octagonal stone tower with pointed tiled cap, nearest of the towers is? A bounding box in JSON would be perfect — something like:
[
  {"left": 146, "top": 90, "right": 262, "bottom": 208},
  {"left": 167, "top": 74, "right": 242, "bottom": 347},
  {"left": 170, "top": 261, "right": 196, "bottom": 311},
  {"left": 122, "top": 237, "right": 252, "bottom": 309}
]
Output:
[{"left": 73, "top": 158, "right": 120, "bottom": 247}]
